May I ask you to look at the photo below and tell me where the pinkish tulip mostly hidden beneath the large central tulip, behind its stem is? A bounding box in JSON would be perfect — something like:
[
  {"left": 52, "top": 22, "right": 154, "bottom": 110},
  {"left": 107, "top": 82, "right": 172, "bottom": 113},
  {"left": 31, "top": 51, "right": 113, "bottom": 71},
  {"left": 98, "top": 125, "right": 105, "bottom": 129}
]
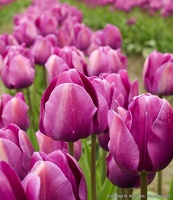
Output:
[{"left": 36, "top": 131, "right": 82, "bottom": 160}]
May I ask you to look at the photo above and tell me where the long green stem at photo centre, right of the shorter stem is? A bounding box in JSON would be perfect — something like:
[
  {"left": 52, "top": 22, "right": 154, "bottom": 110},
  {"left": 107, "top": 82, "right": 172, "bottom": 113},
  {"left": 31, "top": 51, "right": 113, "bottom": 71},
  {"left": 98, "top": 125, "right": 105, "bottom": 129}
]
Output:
[{"left": 91, "top": 134, "right": 96, "bottom": 200}]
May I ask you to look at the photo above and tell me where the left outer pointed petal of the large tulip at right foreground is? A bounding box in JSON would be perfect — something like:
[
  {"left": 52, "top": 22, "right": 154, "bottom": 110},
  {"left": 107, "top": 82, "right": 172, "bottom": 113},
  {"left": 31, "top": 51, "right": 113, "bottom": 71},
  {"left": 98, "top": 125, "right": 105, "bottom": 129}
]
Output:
[{"left": 108, "top": 110, "right": 139, "bottom": 173}]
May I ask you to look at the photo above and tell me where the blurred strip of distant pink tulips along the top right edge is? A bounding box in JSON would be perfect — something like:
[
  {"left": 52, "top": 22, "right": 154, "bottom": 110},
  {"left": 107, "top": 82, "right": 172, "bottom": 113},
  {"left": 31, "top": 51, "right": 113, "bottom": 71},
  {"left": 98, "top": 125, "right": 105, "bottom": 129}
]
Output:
[{"left": 85, "top": 0, "right": 173, "bottom": 17}]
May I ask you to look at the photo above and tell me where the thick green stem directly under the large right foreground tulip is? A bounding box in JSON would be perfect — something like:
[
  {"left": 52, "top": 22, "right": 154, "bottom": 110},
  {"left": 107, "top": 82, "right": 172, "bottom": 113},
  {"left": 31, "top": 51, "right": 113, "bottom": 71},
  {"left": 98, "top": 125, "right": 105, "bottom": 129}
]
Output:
[{"left": 140, "top": 172, "right": 148, "bottom": 200}]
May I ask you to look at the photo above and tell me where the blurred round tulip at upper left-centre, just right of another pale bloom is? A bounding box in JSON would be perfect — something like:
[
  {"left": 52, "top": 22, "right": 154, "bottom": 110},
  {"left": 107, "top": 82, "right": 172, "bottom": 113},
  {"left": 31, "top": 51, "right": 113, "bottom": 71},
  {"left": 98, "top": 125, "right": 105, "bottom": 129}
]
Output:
[{"left": 36, "top": 11, "right": 58, "bottom": 36}]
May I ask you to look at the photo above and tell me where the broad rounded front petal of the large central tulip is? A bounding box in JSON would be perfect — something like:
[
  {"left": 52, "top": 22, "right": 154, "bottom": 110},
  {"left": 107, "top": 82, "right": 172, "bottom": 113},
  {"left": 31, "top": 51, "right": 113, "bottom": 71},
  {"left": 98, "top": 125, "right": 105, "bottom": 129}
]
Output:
[{"left": 44, "top": 83, "right": 96, "bottom": 142}]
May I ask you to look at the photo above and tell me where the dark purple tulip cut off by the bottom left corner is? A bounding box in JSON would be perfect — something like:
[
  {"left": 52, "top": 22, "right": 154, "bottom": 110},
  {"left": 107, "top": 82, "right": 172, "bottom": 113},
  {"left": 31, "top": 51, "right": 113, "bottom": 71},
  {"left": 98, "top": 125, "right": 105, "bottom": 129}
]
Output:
[{"left": 0, "top": 161, "right": 27, "bottom": 200}]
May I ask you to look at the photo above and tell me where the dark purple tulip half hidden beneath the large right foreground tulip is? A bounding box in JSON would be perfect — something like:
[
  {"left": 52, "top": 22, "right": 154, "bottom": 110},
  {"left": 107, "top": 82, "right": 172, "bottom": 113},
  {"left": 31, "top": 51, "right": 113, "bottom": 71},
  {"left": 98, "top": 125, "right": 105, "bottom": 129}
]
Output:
[{"left": 106, "top": 154, "right": 156, "bottom": 188}]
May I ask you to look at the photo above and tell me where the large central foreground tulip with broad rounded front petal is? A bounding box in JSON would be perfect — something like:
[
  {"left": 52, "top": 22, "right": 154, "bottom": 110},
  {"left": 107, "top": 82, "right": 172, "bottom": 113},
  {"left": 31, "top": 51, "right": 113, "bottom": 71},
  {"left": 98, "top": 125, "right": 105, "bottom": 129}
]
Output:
[{"left": 39, "top": 69, "right": 107, "bottom": 142}]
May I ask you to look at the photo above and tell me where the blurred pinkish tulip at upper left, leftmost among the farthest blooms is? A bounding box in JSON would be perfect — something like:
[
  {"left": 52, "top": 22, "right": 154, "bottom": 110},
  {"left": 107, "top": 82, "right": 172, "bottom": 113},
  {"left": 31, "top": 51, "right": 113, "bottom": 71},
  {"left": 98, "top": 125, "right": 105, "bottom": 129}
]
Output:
[{"left": 14, "top": 18, "right": 38, "bottom": 46}]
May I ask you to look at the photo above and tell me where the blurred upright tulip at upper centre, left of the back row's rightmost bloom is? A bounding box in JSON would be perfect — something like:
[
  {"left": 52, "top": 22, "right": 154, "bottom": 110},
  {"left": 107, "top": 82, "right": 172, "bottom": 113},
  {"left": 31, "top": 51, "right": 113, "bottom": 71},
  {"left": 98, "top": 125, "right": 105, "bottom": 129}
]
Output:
[{"left": 72, "top": 23, "right": 92, "bottom": 51}]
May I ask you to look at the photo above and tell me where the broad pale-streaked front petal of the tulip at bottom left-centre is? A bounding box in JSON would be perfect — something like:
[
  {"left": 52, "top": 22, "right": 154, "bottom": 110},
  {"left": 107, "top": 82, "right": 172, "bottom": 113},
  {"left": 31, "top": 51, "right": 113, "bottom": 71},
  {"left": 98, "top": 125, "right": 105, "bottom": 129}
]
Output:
[{"left": 31, "top": 161, "right": 75, "bottom": 200}]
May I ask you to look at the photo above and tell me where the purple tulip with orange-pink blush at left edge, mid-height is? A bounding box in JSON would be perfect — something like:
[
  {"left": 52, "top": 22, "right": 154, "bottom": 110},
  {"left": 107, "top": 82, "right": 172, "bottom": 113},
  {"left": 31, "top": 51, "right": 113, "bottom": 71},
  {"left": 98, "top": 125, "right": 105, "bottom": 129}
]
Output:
[{"left": 0, "top": 92, "right": 30, "bottom": 131}]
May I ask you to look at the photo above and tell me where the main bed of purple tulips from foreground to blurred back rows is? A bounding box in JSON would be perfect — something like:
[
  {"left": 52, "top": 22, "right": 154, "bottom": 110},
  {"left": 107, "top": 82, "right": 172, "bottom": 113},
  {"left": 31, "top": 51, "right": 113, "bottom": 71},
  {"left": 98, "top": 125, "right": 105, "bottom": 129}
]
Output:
[{"left": 0, "top": 0, "right": 173, "bottom": 200}]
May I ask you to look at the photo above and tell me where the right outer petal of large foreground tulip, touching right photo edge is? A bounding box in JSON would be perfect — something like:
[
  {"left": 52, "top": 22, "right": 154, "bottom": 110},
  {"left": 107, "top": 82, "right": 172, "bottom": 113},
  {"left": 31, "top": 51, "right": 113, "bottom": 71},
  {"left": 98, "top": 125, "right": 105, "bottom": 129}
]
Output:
[{"left": 148, "top": 99, "right": 173, "bottom": 171}]
